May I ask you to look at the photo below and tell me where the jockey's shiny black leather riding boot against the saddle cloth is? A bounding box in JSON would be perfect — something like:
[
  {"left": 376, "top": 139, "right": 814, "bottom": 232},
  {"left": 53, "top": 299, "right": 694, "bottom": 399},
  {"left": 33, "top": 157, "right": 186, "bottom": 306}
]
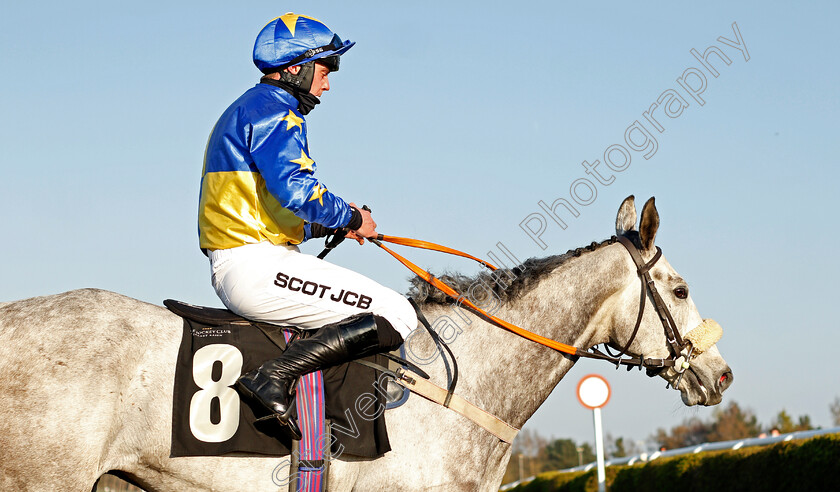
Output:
[{"left": 234, "top": 313, "right": 402, "bottom": 439}]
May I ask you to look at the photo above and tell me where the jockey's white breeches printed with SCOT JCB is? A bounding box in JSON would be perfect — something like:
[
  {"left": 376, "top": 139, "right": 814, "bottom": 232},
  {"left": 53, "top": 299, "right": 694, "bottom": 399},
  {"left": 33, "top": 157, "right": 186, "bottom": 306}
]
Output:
[{"left": 210, "top": 241, "right": 417, "bottom": 338}]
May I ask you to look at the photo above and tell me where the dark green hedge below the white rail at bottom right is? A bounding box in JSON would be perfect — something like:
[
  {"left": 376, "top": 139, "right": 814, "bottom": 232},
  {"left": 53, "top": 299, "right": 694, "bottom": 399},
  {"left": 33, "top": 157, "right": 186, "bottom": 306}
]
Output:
[{"left": 512, "top": 434, "right": 840, "bottom": 492}]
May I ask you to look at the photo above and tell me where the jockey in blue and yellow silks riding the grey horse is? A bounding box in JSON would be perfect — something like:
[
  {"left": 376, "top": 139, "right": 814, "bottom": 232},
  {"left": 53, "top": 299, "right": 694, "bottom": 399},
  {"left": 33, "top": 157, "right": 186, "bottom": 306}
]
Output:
[{"left": 198, "top": 13, "right": 417, "bottom": 435}]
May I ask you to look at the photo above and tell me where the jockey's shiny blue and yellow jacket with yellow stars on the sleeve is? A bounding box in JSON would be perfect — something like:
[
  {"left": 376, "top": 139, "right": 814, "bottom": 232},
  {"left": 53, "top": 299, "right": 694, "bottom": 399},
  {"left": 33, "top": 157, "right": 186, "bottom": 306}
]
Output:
[{"left": 198, "top": 84, "right": 352, "bottom": 251}]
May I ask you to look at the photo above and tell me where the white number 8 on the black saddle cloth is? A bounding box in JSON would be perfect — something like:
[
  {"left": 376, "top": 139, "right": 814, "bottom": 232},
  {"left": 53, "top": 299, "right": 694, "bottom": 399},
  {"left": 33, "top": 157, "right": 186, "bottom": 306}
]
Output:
[{"left": 190, "top": 343, "right": 242, "bottom": 442}]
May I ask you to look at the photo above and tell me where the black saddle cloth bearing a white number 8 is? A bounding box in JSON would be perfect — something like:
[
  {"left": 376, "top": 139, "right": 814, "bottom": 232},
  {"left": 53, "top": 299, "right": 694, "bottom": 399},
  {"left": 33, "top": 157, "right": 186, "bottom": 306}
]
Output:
[{"left": 164, "top": 299, "right": 398, "bottom": 458}]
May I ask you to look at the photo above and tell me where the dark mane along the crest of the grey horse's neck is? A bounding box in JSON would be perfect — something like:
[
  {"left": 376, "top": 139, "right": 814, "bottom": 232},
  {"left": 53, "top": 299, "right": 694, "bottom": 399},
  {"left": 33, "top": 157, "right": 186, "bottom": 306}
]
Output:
[{"left": 408, "top": 236, "right": 624, "bottom": 304}]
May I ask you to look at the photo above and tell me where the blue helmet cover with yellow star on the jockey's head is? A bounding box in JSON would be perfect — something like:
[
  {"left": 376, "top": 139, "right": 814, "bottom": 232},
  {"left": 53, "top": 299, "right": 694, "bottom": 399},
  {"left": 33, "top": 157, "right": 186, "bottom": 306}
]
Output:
[{"left": 254, "top": 12, "right": 356, "bottom": 74}]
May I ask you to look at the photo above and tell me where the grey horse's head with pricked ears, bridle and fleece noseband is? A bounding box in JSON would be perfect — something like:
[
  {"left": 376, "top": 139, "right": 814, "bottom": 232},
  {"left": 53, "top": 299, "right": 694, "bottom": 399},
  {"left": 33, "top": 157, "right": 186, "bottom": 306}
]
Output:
[{"left": 610, "top": 195, "right": 733, "bottom": 405}]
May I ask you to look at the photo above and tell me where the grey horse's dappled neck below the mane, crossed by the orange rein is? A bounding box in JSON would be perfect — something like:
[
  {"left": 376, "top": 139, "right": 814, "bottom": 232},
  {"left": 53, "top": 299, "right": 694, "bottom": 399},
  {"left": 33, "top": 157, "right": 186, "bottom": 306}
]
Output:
[{"left": 420, "top": 245, "right": 627, "bottom": 427}]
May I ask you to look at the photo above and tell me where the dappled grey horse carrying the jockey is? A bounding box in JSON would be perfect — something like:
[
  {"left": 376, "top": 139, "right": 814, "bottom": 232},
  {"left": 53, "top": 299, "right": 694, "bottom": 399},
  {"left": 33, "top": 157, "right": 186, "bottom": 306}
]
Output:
[{"left": 0, "top": 197, "right": 732, "bottom": 491}]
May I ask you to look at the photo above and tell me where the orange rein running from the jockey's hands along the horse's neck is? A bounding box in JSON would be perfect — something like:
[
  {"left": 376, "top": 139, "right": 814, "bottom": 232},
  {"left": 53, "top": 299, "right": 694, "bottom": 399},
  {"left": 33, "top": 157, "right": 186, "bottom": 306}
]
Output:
[{"left": 368, "top": 234, "right": 578, "bottom": 355}]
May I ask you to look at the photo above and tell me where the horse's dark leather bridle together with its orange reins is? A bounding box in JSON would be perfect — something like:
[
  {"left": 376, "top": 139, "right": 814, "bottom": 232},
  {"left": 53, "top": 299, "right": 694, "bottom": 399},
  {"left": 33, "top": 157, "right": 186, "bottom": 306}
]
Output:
[{"left": 368, "top": 234, "right": 694, "bottom": 389}]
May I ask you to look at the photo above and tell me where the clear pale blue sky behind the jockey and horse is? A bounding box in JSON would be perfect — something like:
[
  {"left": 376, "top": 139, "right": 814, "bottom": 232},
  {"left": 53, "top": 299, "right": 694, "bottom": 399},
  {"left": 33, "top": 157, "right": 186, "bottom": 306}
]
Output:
[{"left": 0, "top": 0, "right": 840, "bottom": 450}]
